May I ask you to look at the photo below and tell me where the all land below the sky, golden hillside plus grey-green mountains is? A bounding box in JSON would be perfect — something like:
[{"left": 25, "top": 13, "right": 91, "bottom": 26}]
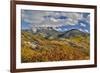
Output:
[{"left": 21, "top": 29, "right": 90, "bottom": 62}]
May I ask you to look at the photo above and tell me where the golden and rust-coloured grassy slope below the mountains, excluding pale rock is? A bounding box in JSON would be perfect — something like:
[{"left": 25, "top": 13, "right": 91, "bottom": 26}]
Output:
[{"left": 21, "top": 32, "right": 89, "bottom": 62}]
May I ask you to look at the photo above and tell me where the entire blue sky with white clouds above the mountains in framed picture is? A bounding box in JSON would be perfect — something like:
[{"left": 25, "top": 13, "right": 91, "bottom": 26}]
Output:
[{"left": 21, "top": 10, "right": 90, "bottom": 33}]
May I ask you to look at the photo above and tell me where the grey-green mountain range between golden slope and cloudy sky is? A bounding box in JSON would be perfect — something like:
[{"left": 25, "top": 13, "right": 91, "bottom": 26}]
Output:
[{"left": 22, "top": 29, "right": 90, "bottom": 39}]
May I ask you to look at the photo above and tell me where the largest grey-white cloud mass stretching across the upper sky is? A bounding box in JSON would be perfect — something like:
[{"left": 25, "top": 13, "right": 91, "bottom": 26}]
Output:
[{"left": 22, "top": 10, "right": 89, "bottom": 27}]
